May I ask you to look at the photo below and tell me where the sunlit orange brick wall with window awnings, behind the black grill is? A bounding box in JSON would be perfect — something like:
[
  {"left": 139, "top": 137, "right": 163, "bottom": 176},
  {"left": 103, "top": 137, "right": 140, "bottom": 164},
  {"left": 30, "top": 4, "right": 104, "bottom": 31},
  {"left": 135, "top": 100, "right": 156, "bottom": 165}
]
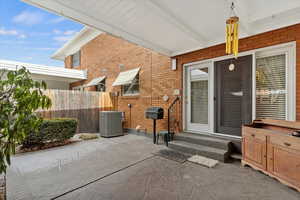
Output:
[{"left": 65, "top": 34, "right": 181, "bottom": 132}]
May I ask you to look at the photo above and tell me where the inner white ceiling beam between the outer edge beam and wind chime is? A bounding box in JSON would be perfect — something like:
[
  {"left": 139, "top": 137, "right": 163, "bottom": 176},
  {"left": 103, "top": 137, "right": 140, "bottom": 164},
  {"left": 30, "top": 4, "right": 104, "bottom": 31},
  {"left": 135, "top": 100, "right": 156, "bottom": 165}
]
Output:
[{"left": 135, "top": 0, "right": 208, "bottom": 45}]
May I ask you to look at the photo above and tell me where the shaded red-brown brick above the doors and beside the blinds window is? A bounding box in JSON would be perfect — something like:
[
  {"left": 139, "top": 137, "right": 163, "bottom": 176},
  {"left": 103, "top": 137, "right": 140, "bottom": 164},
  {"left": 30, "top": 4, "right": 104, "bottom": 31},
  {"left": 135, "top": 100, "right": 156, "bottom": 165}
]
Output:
[{"left": 176, "top": 24, "right": 300, "bottom": 120}]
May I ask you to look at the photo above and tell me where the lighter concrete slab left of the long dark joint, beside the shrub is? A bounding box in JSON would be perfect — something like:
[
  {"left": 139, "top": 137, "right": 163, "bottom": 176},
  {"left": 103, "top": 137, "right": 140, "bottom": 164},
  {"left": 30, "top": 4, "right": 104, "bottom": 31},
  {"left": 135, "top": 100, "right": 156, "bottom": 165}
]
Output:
[{"left": 7, "top": 135, "right": 164, "bottom": 200}]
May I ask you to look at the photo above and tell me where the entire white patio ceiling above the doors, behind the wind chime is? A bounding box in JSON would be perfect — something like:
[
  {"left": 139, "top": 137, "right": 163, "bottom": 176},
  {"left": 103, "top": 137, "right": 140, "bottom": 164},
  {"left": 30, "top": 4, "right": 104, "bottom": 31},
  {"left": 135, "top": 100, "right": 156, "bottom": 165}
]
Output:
[{"left": 23, "top": 0, "right": 300, "bottom": 56}]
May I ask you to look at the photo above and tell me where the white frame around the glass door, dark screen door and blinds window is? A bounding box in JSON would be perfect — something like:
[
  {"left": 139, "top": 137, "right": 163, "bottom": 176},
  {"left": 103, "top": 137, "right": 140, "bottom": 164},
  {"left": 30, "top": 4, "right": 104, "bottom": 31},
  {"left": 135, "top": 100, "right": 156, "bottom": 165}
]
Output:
[{"left": 182, "top": 41, "right": 296, "bottom": 138}]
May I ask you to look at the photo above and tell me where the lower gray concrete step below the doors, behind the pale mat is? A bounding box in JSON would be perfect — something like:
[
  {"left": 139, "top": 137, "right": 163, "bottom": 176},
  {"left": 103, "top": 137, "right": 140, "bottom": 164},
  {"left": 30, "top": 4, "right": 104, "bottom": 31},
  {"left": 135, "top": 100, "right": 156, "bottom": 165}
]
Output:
[{"left": 169, "top": 140, "right": 230, "bottom": 162}]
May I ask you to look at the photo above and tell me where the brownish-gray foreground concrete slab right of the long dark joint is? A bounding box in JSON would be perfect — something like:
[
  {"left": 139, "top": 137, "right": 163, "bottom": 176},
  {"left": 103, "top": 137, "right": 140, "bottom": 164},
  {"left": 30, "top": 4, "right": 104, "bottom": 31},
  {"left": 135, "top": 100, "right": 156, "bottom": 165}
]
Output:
[{"left": 59, "top": 157, "right": 300, "bottom": 200}]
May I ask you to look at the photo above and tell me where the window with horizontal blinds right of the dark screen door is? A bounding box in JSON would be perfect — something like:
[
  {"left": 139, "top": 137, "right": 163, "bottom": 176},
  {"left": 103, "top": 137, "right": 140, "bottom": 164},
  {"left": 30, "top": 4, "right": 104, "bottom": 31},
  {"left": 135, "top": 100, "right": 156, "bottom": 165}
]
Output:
[{"left": 256, "top": 54, "right": 287, "bottom": 120}]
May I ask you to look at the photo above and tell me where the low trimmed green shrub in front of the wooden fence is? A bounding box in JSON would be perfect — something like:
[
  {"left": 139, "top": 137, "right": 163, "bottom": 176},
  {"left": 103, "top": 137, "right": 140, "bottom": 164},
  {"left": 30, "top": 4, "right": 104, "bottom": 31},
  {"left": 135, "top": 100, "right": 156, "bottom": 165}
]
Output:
[{"left": 22, "top": 118, "right": 77, "bottom": 147}]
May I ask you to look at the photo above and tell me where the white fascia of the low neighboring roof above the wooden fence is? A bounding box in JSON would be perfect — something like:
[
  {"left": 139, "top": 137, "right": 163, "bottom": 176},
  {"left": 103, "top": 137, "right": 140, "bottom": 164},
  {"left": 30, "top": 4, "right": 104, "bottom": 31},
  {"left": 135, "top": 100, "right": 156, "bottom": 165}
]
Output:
[{"left": 0, "top": 60, "right": 87, "bottom": 81}]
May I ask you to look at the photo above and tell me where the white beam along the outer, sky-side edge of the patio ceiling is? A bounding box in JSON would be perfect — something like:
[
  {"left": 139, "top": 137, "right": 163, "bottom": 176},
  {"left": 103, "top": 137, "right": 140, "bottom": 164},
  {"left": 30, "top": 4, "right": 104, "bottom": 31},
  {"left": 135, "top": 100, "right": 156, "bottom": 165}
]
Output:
[{"left": 22, "top": 0, "right": 172, "bottom": 56}]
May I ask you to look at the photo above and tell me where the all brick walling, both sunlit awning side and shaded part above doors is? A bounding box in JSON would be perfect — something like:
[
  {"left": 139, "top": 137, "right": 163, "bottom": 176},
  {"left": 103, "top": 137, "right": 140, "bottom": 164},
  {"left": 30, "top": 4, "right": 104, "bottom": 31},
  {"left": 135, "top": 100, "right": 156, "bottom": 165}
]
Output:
[{"left": 65, "top": 24, "right": 300, "bottom": 132}]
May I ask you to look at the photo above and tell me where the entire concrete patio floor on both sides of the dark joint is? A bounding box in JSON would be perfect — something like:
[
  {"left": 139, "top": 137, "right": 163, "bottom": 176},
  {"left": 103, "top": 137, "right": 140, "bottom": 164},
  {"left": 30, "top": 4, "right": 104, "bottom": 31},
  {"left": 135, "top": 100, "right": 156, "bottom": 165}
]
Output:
[{"left": 7, "top": 135, "right": 300, "bottom": 200}]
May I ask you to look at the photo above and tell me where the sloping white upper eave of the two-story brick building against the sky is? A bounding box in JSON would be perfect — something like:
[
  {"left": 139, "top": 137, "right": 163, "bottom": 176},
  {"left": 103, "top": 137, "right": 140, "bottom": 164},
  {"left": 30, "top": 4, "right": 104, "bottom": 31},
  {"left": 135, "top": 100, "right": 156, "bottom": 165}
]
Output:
[{"left": 51, "top": 26, "right": 102, "bottom": 61}]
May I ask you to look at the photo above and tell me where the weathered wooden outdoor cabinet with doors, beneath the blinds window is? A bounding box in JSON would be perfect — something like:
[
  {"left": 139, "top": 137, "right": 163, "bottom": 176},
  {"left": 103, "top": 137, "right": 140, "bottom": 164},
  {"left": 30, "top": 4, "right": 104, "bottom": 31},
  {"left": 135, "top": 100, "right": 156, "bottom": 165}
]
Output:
[{"left": 242, "top": 119, "right": 300, "bottom": 191}]
